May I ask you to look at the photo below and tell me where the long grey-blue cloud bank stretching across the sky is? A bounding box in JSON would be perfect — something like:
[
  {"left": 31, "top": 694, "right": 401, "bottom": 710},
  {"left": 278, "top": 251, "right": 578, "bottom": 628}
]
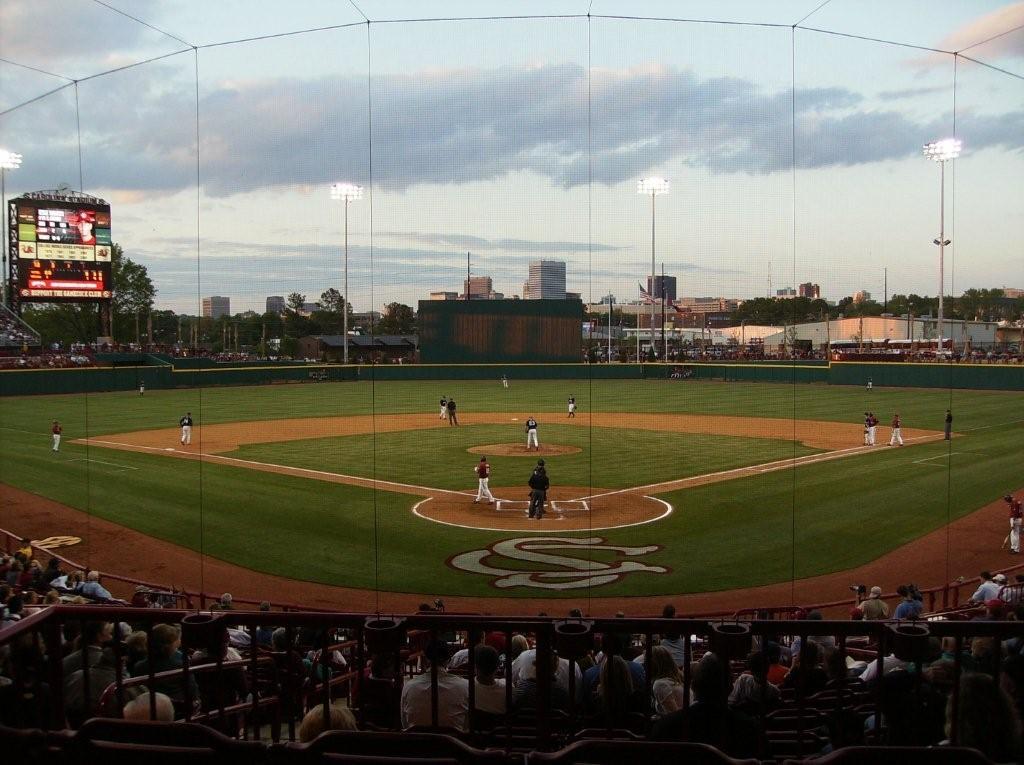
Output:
[{"left": 8, "top": 62, "right": 1024, "bottom": 197}]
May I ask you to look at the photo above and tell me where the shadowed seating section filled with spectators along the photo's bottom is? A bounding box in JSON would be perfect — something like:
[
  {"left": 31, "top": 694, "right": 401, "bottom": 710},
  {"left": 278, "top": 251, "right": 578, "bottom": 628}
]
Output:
[{"left": 0, "top": 602, "right": 1024, "bottom": 765}]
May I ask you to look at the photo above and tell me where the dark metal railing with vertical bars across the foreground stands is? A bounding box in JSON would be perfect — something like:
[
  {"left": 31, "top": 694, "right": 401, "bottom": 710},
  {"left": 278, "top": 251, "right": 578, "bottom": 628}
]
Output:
[{"left": 0, "top": 605, "right": 1024, "bottom": 754}]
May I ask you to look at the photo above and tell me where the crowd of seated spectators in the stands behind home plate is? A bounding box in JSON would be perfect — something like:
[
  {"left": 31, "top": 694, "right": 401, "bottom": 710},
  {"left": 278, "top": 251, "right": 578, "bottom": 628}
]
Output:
[{"left": 0, "top": 561, "right": 1024, "bottom": 762}]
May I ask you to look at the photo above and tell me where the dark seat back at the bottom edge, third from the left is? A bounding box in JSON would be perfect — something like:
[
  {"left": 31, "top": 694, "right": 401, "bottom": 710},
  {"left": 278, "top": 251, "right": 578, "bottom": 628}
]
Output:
[{"left": 526, "top": 739, "right": 758, "bottom": 765}]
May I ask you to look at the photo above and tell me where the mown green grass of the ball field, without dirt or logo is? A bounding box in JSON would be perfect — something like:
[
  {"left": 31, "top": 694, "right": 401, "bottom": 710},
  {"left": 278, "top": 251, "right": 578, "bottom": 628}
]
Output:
[{"left": 0, "top": 378, "right": 1024, "bottom": 597}]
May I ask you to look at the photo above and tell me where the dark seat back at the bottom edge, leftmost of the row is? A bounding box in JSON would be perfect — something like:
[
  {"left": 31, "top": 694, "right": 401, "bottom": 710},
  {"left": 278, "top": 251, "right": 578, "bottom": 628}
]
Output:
[{"left": 68, "top": 718, "right": 267, "bottom": 765}]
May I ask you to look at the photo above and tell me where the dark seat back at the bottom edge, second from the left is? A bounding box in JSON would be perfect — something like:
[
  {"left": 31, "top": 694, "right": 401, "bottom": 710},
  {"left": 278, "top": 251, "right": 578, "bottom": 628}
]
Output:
[{"left": 270, "top": 730, "right": 508, "bottom": 765}]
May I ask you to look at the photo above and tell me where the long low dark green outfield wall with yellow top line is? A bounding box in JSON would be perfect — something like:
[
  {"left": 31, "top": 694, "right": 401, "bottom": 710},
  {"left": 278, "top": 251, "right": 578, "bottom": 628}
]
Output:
[{"left": 0, "top": 356, "right": 1024, "bottom": 396}]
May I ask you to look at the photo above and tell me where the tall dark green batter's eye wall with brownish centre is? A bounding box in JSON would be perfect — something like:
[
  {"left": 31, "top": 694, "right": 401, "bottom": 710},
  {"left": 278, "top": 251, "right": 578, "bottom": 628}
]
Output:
[{"left": 417, "top": 300, "right": 583, "bottom": 364}]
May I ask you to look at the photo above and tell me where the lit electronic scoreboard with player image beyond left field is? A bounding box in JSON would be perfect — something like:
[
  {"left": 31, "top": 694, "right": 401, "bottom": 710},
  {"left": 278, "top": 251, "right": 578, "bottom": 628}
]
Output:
[{"left": 7, "top": 193, "right": 113, "bottom": 303}]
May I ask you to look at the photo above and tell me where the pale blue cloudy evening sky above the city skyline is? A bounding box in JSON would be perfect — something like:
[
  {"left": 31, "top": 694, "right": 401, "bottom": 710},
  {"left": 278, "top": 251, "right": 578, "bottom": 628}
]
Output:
[{"left": 0, "top": 0, "right": 1024, "bottom": 311}]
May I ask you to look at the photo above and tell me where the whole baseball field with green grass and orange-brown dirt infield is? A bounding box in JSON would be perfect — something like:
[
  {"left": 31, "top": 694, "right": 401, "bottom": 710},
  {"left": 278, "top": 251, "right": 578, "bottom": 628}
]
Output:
[{"left": 0, "top": 379, "right": 1024, "bottom": 599}]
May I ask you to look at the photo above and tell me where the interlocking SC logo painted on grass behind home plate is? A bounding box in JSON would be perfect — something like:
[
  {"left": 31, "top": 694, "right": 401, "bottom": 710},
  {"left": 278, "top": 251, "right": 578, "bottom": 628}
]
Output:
[{"left": 449, "top": 537, "right": 669, "bottom": 590}]
